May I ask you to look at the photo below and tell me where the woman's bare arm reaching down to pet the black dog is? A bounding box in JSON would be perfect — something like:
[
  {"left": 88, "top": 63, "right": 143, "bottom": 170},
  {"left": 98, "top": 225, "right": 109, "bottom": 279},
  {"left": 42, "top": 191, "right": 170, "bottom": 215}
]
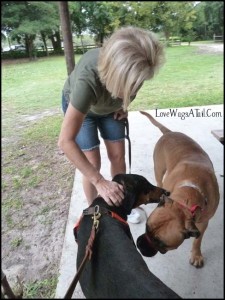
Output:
[{"left": 58, "top": 103, "right": 124, "bottom": 206}]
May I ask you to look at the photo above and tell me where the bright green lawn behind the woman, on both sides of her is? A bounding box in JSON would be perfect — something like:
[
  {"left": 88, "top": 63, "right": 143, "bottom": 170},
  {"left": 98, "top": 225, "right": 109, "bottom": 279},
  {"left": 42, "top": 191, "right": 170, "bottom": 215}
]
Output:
[{"left": 2, "top": 46, "right": 223, "bottom": 117}]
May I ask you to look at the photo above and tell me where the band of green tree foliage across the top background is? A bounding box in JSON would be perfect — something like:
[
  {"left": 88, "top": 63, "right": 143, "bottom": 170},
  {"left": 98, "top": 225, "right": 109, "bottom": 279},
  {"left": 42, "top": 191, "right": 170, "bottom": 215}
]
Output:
[{"left": 1, "top": 1, "right": 224, "bottom": 56}]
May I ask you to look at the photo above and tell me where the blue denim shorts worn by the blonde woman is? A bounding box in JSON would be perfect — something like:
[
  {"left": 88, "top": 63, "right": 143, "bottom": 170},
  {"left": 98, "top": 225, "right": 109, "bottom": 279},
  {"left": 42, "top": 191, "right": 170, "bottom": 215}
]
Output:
[{"left": 62, "top": 90, "right": 125, "bottom": 151}]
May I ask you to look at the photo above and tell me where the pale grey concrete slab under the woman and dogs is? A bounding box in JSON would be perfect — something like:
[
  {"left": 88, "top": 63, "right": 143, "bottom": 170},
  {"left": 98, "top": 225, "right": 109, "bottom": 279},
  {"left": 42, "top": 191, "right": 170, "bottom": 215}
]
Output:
[{"left": 55, "top": 105, "right": 224, "bottom": 299}]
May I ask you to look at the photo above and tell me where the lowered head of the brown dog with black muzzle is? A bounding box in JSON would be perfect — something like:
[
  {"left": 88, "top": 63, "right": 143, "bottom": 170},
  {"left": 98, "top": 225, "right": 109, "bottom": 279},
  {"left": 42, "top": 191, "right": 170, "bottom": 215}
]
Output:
[{"left": 137, "top": 197, "right": 200, "bottom": 257}]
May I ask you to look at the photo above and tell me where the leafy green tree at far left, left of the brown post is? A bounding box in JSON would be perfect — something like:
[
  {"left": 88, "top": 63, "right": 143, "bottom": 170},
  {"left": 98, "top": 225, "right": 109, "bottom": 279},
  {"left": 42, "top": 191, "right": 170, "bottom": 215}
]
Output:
[{"left": 2, "top": 1, "right": 59, "bottom": 59}]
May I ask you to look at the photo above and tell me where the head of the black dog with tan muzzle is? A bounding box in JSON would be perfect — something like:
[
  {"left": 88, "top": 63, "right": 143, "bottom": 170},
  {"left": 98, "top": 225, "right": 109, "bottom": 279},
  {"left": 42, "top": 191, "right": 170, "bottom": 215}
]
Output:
[{"left": 112, "top": 174, "right": 169, "bottom": 214}]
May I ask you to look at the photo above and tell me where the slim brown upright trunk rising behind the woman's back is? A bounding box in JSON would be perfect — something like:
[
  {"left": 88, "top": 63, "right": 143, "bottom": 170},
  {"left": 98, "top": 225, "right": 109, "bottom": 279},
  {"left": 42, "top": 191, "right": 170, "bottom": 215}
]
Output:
[{"left": 59, "top": 1, "right": 75, "bottom": 75}]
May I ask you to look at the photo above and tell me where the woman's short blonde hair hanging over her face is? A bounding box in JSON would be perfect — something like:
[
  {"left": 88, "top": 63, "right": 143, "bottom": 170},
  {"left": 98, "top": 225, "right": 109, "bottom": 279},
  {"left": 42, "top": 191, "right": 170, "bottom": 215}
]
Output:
[{"left": 98, "top": 26, "right": 164, "bottom": 111}]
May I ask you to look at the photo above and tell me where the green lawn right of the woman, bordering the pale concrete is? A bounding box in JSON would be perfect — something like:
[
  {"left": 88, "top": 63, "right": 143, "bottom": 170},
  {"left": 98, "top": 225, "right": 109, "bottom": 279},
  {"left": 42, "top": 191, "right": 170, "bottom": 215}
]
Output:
[{"left": 130, "top": 46, "right": 223, "bottom": 110}]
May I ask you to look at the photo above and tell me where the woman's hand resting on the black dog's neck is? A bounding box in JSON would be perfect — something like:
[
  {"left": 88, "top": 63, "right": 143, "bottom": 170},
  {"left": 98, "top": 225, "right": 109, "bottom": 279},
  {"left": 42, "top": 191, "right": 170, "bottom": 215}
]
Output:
[{"left": 95, "top": 177, "right": 124, "bottom": 206}]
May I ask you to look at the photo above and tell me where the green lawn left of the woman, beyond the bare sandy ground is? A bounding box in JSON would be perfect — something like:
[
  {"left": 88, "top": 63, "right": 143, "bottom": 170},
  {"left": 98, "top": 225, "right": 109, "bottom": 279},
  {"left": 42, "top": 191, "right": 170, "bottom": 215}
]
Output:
[{"left": 2, "top": 56, "right": 80, "bottom": 114}]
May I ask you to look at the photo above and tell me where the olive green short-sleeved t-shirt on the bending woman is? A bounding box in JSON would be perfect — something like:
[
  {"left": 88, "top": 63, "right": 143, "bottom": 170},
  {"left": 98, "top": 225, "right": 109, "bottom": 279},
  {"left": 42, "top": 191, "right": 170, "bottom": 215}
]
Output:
[{"left": 63, "top": 48, "right": 126, "bottom": 115}]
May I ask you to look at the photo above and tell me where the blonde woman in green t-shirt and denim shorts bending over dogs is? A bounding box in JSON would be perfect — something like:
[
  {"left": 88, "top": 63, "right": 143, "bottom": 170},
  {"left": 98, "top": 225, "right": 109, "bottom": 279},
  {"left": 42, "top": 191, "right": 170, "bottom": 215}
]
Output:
[{"left": 58, "top": 27, "right": 164, "bottom": 220}]
